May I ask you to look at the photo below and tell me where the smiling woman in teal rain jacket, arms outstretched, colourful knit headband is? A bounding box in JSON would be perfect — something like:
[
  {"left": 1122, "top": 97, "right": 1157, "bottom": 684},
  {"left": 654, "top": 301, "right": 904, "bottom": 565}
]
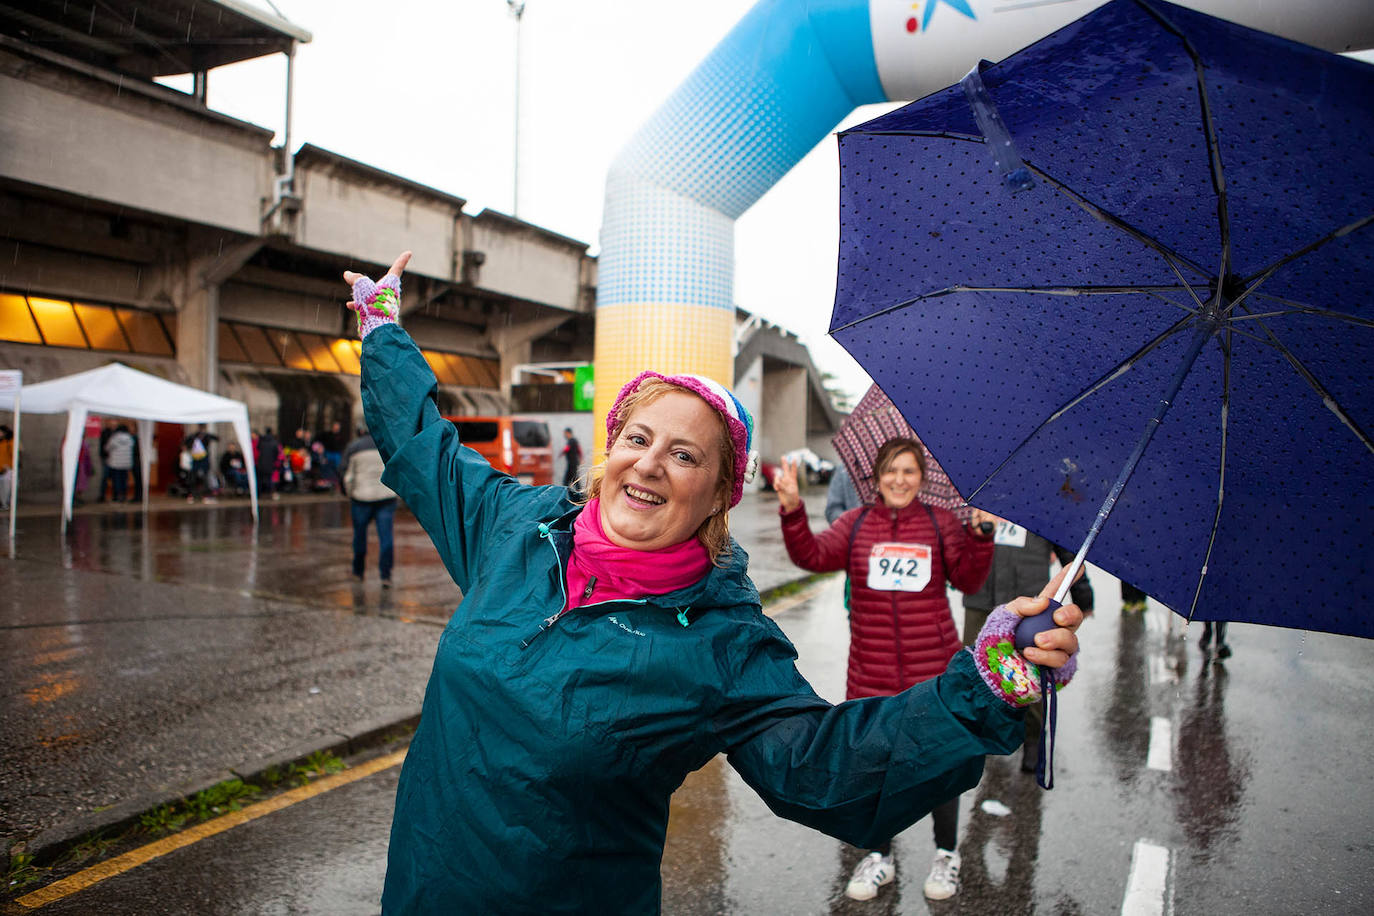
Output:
[{"left": 344, "top": 253, "right": 1079, "bottom": 916}]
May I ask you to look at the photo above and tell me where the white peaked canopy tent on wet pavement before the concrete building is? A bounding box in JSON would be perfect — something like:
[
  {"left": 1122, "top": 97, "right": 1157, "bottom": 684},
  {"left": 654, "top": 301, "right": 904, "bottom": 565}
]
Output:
[{"left": 0, "top": 363, "right": 257, "bottom": 527}]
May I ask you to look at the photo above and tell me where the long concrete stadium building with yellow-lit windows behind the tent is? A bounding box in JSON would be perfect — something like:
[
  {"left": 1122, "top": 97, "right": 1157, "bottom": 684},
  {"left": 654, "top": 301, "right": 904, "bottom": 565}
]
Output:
[{"left": 0, "top": 0, "right": 833, "bottom": 490}]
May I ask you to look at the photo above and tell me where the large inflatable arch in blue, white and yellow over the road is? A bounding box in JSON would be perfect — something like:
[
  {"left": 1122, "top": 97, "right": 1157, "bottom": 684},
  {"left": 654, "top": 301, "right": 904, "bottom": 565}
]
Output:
[{"left": 595, "top": 0, "right": 1374, "bottom": 449}]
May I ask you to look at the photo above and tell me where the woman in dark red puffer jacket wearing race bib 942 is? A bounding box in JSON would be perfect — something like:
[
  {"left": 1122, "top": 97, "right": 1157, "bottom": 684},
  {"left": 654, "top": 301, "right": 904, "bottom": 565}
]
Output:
[{"left": 774, "top": 438, "right": 993, "bottom": 900}]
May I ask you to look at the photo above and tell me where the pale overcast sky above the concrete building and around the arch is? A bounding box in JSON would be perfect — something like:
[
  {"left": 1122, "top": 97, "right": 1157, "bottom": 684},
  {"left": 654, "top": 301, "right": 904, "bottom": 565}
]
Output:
[{"left": 179, "top": 0, "right": 892, "bottom": 397}]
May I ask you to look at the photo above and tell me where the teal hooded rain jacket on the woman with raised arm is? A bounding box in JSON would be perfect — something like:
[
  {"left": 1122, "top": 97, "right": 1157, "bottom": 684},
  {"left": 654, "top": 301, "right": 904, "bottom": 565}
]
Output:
[{"left": 363, "top": 325, "right": 1022, "bottom": 916}]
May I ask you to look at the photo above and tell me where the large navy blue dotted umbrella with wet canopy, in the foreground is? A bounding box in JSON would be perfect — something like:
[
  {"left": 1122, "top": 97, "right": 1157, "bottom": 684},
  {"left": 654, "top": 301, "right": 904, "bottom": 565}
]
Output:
[{"left": 831, "top": 0, "right": 1374, "bottom": 636}]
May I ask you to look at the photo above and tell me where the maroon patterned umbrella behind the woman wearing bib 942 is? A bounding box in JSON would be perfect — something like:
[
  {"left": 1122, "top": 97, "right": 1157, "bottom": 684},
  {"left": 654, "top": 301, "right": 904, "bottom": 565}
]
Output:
[{"left": 830, "top": 385, "right": 973, "bottom": 522}]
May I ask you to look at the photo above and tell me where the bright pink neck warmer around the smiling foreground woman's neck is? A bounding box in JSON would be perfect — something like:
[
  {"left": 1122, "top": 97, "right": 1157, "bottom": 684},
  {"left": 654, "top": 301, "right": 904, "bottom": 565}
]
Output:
[{"left": 566, "top": 500, "right": 710, "bottom": 610}]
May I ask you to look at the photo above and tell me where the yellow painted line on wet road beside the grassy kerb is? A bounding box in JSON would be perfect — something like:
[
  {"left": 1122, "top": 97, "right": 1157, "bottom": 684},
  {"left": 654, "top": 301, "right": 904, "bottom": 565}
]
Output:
[{"left": 15, "top": 748, "right": 405, "bottom": 909}]
